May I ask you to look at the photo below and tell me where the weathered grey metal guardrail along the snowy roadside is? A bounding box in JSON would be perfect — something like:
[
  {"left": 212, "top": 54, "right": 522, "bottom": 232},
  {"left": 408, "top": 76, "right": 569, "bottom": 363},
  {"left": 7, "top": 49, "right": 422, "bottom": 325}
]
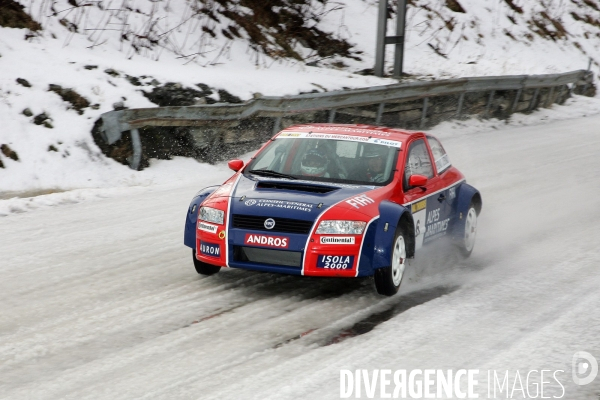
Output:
[{"left": 101, "top": 70, "right": 592, "bottom": 170}]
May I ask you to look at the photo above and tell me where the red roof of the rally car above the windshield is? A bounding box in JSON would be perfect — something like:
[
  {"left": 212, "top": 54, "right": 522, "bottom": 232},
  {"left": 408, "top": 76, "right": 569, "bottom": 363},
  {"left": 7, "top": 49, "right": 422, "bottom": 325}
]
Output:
[{"left": 279, "top": 123, "right": 423, "bottom": 142}]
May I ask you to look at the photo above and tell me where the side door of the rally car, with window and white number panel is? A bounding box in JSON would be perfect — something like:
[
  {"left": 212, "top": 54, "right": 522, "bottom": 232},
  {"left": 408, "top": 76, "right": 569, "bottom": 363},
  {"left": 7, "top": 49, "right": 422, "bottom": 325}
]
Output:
[{"left": 402, "top": 138, "right": 448, "bottom": 249}]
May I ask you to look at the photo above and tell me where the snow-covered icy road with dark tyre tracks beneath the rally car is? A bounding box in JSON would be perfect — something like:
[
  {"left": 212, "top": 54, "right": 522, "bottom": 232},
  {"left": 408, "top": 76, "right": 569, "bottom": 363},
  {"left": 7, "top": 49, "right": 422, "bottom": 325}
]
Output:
[{"left": 0, "top": 116, "right": 600, "bottom": 400}]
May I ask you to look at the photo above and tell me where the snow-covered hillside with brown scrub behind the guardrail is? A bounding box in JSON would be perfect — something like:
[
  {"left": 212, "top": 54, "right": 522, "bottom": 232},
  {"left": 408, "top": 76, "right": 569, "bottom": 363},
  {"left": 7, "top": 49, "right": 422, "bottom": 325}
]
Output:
[{"left": 0, "top": 0, "right": 600, "bottom": 194}]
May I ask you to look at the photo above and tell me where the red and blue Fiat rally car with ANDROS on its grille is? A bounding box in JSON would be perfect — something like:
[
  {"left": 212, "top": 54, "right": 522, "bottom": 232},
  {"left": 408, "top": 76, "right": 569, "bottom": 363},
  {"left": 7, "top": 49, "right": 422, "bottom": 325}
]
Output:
[{"left": 184, "top": 124, "right": 482, "bottom": 296}]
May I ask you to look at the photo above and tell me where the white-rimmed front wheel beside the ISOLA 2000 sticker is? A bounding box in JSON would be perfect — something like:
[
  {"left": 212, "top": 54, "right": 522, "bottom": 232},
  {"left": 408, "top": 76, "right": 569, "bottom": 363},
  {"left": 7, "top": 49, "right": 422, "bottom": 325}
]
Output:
[{"left": 374, "top": 227, "right": 408, "bottom": 296}]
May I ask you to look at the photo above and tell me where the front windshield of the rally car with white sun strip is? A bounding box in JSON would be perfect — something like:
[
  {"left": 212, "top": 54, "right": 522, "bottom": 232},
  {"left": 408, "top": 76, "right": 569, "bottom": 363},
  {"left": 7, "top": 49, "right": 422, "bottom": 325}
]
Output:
[{"left": 244, "top": 133, "right": 400, "bottom": 186}]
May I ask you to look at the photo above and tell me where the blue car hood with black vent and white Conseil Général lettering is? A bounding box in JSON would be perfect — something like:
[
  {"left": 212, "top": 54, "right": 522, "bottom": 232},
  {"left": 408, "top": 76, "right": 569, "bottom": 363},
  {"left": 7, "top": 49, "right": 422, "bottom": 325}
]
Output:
[{"left": 231, "top": 174, "right": 375, "bottom": 221}]
